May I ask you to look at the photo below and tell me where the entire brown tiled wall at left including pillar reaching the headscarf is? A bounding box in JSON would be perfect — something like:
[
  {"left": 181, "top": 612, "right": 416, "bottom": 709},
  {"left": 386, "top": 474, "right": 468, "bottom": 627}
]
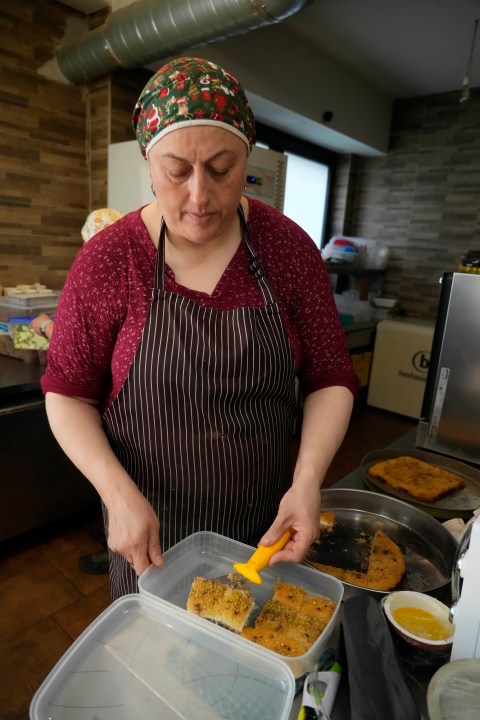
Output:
[{"left": 0, "top": 0, "right": 146, "bottom": 289}]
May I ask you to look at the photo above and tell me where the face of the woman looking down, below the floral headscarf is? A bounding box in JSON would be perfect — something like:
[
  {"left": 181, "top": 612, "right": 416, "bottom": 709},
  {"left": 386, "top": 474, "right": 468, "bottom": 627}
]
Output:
[{"left": 148, "top": 125, "right": 248, "bottom": 244}]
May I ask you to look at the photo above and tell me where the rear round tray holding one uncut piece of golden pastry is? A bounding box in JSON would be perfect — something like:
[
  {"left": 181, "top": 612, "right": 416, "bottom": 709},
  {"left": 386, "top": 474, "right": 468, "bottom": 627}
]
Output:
[{"left": 361, "top": 448, "right": 480, "bottom": 520}]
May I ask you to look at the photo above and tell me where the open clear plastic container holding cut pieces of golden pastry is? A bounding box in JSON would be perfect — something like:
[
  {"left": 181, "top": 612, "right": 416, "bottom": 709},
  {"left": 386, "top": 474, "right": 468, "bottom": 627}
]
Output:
[{"left": 138, "top": 531, "right": 343, "bottom": 678}]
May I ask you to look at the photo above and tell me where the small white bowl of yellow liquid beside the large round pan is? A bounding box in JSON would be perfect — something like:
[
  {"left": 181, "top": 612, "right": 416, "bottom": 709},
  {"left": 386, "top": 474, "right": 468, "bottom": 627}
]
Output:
[{"left": 381, "top": 590, "right": 455, "bottom": 652}]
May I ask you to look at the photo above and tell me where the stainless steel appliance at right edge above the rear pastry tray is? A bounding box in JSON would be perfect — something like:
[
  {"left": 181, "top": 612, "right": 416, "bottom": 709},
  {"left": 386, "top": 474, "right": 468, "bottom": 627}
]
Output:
[{"left": 416, "top": 272, "right": 480, "bottom": 465}]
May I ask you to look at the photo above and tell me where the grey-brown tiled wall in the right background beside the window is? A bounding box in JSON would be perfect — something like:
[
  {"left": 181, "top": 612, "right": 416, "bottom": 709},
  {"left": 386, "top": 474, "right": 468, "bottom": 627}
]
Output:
[{"left": 333, "top": 89, "right": 480, "bottom": 317}]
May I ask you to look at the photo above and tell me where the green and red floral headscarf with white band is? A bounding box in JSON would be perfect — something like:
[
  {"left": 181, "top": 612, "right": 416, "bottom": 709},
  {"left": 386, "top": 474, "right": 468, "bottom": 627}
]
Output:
[{"left": 132, "top": 58, "right": 255, "bottom": 158}]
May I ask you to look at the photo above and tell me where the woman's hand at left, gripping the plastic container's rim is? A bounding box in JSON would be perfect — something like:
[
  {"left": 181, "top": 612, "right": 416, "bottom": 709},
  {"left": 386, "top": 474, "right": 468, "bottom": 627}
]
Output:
[{"left": 107, "top": 485, "right": 163, "bottom": 575}]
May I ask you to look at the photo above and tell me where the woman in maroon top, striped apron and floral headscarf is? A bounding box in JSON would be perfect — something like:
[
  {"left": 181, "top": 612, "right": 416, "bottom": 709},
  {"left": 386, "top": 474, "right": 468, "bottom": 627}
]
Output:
[{"left": 43, "top": 58, "right": 357, "bottom": 598}]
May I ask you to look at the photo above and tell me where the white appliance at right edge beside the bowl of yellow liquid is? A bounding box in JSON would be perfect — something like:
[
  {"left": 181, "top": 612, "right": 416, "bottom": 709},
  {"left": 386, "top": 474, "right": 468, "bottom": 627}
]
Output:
[{"left": 450, "top": 515, "right": 480, "bottom": 660}]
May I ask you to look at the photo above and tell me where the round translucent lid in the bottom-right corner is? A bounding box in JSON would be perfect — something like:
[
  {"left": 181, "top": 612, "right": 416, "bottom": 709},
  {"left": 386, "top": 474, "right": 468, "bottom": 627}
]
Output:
[{"left": 427, "top": 659, "right": 480, "bottom": 720}]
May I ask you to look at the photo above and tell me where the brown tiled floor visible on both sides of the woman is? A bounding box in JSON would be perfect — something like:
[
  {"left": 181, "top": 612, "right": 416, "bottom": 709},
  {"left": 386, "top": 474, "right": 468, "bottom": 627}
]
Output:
[{"left": 0, "top": 406, "right": 417, "bottom": 720}]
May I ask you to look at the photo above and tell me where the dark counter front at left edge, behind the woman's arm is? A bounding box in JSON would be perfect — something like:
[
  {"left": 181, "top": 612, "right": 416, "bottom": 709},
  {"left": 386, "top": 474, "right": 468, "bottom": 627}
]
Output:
[{"left": 0, "top": 356, "right": 99, "bottom": 541}]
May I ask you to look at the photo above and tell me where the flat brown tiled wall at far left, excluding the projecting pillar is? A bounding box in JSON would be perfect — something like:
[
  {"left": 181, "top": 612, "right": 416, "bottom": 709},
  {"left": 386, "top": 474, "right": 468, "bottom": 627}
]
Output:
[{"left": 0, "top": 0, "right": 87, "bottom": 288}]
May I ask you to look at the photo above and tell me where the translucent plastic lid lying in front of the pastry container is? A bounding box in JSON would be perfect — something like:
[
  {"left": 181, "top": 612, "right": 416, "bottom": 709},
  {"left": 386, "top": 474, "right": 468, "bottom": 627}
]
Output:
[{"left": 30, "top": 595, "right": 295, "bottom": 720}]
